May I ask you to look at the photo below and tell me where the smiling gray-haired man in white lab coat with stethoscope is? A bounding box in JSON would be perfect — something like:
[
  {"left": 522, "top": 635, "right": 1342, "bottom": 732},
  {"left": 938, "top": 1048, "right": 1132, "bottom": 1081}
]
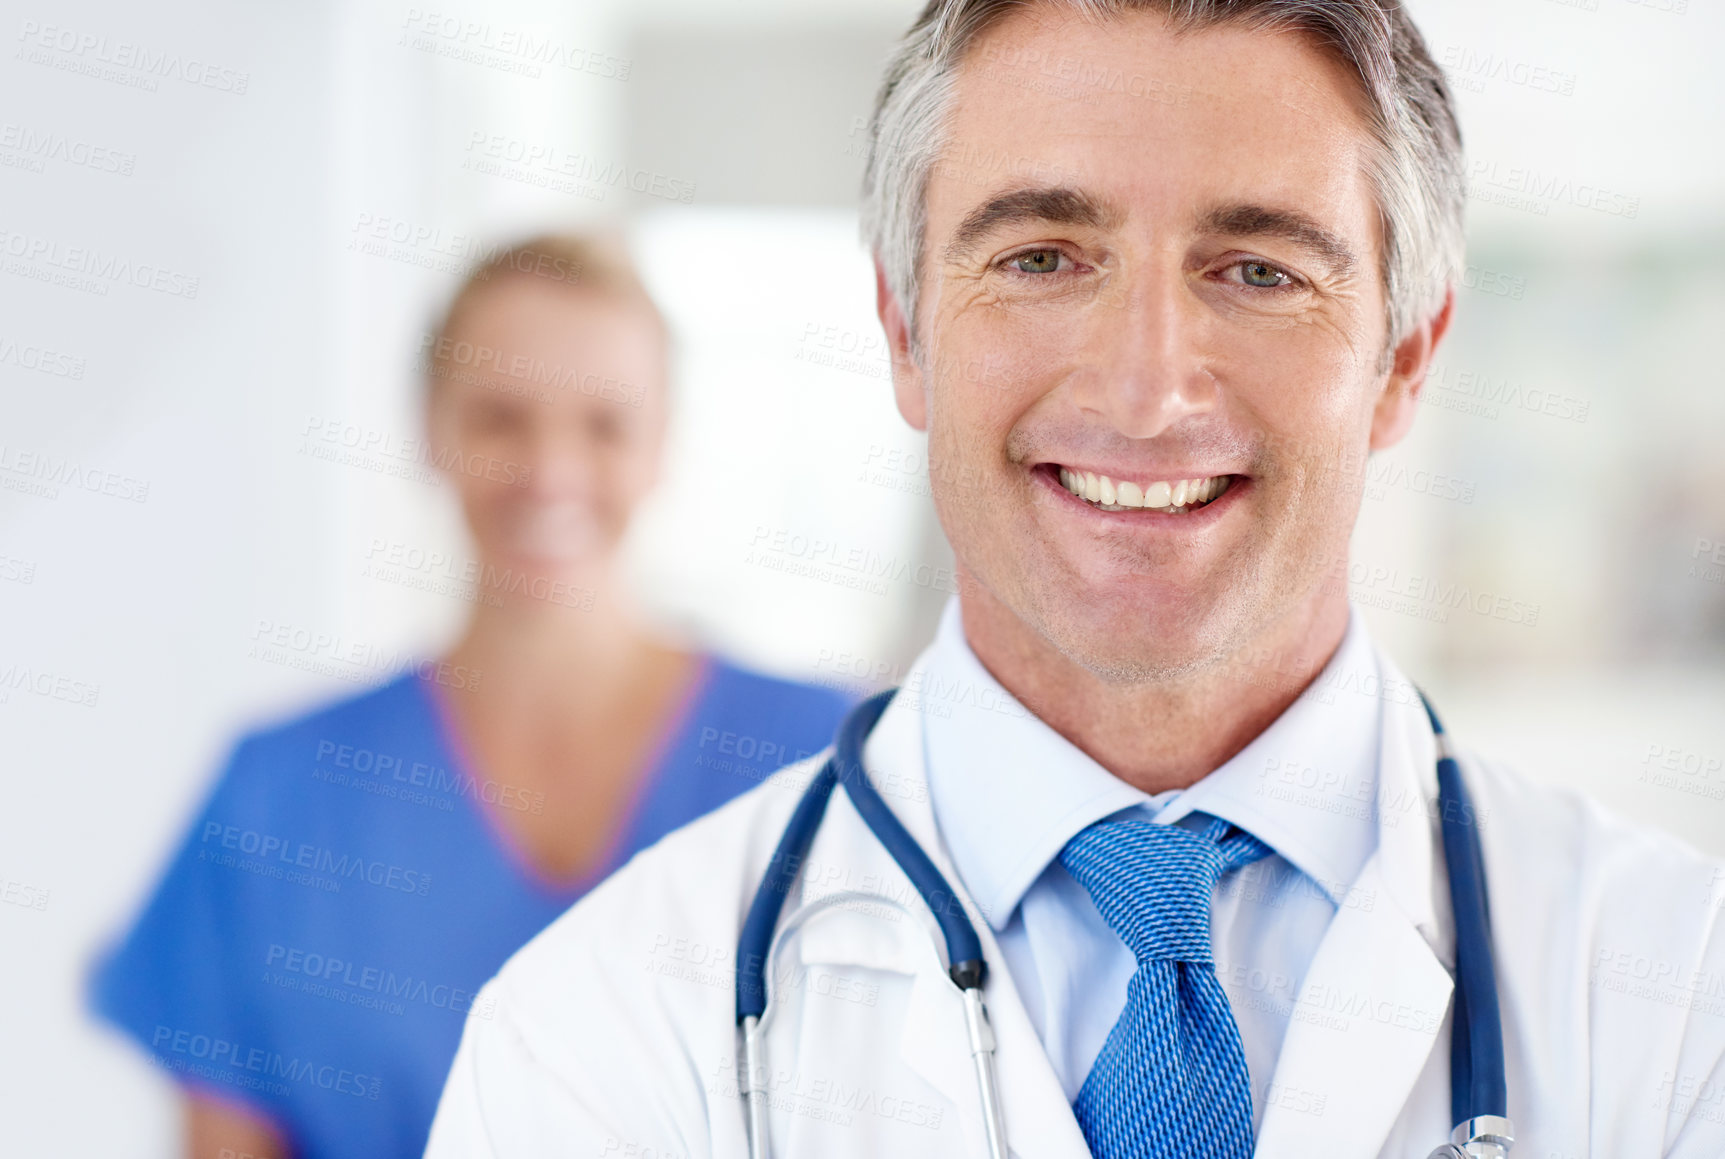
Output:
[{"left": 430, "top": 0, "right": 1725, "bottom": 1159}]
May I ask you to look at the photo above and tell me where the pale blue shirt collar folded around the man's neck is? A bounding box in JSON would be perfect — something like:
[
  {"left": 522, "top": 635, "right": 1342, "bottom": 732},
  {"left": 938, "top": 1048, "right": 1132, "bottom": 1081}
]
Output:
[{"left": 906, "top": 598, "right": 1380, "bottom": 930}]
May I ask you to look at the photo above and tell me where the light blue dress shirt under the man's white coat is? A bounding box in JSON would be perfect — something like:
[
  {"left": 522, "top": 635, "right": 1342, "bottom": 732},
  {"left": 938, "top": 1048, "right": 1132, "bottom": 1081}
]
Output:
[{"left": 907, "top": 598, "right": 1380, "bottom": 1128}]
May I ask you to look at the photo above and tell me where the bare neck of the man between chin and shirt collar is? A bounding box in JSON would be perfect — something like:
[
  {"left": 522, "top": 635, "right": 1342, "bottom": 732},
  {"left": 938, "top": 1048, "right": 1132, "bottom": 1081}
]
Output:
[{"left": 961, "top": 581, "right": 1347, "bottom": 793}]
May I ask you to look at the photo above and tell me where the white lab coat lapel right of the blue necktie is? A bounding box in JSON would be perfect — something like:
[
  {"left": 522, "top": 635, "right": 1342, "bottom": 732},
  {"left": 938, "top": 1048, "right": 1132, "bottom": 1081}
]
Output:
[{"left": 1258, "top": 669, "right": 1454, "bottom": 1159}]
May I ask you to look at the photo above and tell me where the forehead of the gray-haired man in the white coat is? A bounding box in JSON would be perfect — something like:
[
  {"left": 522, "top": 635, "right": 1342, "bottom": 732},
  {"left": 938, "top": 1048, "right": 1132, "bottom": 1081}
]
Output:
[{"left": 930, "top": 5, "right": 1371, "bottom": 248}]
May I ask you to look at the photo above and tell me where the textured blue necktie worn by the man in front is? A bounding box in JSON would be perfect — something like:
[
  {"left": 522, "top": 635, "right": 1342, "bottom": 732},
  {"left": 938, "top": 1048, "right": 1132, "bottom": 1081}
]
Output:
[{"left": 1061, "top": 818, "right": 1270, "bottom": 1159}]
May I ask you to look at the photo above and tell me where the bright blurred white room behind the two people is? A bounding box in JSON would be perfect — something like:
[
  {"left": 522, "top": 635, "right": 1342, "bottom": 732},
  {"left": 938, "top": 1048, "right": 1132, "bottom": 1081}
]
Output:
[{"left": 0, "top": 0, "right": 1725, "bottom": 1159}]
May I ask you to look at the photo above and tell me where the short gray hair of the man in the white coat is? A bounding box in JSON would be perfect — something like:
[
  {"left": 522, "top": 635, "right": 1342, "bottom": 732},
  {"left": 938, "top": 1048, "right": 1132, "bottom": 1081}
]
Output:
[{"left": 863, "top": 0, "right": 1465, "bottom": 357}]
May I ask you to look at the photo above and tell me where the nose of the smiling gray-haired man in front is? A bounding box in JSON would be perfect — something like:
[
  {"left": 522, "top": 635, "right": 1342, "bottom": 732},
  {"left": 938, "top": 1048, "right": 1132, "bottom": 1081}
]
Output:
[{"left": 1076, "top": 271, "right": 1220, "bottom": 438}]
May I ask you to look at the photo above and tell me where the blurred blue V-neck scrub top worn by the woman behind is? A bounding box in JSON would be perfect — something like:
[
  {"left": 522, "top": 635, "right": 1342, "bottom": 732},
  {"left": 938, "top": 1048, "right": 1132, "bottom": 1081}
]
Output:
[{"left": 91, "top": 661, "right": 847, "bottom": 1159}]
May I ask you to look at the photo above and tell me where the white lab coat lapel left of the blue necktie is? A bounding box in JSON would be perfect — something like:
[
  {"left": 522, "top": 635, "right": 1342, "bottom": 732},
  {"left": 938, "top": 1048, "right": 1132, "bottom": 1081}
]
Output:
[{"left": 856, "top": 685, "right": 1090, "bottom": 1159}]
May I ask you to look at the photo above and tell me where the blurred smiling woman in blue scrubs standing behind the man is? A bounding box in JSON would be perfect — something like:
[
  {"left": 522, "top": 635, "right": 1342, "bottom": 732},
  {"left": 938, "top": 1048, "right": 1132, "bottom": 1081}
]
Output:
[{"left": 93, "top": 238, "right": 845, "bottom": 1159}]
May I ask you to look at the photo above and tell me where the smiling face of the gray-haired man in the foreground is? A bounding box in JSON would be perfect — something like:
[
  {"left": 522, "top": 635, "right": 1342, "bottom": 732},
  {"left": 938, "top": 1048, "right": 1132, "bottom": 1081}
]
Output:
[{"left": 883, "top": 9, "right": 1428, "bottom": 681}]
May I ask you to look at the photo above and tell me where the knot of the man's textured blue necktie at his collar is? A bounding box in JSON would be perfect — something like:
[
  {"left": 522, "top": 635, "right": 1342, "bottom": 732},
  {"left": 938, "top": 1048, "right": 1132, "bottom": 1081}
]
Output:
[{"left": 1061, "top": 818, "right": 1270, "bottom": 966}]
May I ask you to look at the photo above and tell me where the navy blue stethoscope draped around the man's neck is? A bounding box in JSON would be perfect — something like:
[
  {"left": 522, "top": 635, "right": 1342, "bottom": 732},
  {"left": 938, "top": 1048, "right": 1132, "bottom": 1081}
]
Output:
[{"left": 737, "top": 690, "right": 1515, "bottom": 1159}]
